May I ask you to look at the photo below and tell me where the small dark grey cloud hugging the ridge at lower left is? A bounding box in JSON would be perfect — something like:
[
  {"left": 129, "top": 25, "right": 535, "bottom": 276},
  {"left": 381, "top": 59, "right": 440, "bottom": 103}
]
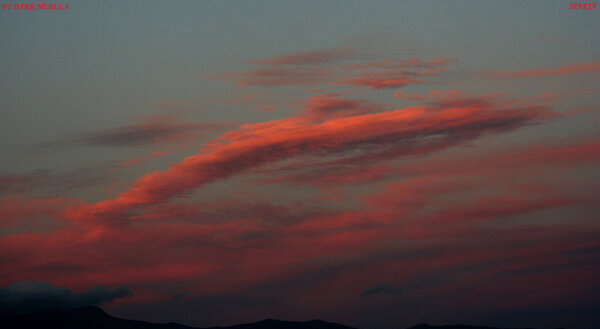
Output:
[{"left": 0, "top": 281, "right": 133, "bottom": 314}]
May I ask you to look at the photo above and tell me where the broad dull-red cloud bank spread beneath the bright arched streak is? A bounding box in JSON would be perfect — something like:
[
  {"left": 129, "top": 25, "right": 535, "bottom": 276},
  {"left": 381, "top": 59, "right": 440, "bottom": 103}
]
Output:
[{"left": 0, "top": 135, "right": 600, "bottom": 316}]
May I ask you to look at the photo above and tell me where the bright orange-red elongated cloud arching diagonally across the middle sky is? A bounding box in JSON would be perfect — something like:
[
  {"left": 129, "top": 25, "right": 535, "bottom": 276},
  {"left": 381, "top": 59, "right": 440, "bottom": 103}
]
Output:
[{"left": 64, "top": 92, "right": 553, "bottom": 217}]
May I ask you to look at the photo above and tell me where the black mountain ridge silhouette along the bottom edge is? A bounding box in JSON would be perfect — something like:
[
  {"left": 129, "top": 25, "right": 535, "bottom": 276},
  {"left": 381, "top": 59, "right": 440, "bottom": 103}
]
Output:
[{"left": 0, "top": 306, "right": 556, "bottom": 329}]
